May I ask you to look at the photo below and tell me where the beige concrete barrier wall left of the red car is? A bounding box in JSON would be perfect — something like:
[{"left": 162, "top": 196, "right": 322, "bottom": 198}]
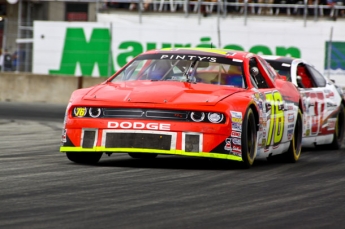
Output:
[{"left": 0, "top": 72, "right": 105, "bottom": 104}]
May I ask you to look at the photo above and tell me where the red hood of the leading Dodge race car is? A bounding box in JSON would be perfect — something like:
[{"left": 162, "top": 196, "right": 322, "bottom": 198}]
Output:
[{"left": 83, "top": 81, "right": 244, "bottom": 105}]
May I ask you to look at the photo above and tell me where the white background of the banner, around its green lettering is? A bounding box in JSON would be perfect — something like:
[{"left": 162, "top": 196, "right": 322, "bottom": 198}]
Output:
[{"left": 33, "top": 14, "right": 345, "bottom": 86}]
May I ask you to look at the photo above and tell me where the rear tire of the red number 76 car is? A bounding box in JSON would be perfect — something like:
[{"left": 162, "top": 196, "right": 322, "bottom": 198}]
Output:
[{"left": 284, "top": 109, "right": 303, "bottom": 163}]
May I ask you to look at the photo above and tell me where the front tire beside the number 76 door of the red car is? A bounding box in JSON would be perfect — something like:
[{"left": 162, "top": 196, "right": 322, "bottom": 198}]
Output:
[{"left": 241, "top": 108, "right": 257, "bottom": 168}]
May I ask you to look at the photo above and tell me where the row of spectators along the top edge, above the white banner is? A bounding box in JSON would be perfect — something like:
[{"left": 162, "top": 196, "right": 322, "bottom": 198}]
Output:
[{"left": 105, "top": 0, "right": 345, "bottom": 18}]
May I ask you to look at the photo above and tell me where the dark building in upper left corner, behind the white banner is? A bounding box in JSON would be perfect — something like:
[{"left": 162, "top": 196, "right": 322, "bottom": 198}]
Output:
[{"left": 0, "top": 0, "right": 98, "bottom": 72}]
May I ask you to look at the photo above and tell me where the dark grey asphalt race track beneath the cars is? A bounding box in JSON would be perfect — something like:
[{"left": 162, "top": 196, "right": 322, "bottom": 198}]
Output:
[{"left": 0, "top": 102, "right": 345, "bottom": 229}]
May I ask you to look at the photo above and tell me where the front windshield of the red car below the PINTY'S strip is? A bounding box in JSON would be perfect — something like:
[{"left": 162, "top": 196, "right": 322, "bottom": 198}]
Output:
[{"left": 112, "top": 55, "right": 245, "bottom": 88}]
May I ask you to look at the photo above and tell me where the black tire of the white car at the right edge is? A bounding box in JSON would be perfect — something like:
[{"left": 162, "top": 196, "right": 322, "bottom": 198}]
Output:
[{"left": 328, "top": 104, "right": 345, "bottom": 150}]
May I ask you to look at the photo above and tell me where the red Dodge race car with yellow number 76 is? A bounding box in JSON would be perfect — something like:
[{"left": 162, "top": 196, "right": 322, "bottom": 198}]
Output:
[{"left": 60, "top": 48, "right": 304, "bottom": 167}]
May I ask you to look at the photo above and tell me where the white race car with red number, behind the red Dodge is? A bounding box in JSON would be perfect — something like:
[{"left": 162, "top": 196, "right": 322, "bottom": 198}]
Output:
[{"left": 262, "top": 56, "right": 345, "bottom": 149}]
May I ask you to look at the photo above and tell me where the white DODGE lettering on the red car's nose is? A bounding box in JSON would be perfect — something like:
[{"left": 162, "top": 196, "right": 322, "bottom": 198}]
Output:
[{"left": 107, "top": 122, "right": 170, "bottom": 130}]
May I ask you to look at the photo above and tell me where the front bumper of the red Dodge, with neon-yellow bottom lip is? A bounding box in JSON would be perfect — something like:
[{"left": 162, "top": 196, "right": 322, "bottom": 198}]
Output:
[{"left": 60, "top": 120, "right": 242, "bottom": 161}]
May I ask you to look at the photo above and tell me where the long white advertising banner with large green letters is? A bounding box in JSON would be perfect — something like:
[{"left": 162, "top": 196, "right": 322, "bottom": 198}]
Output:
[{"left": 33, "top": 14, "right": 345, "bottom": 84}]
